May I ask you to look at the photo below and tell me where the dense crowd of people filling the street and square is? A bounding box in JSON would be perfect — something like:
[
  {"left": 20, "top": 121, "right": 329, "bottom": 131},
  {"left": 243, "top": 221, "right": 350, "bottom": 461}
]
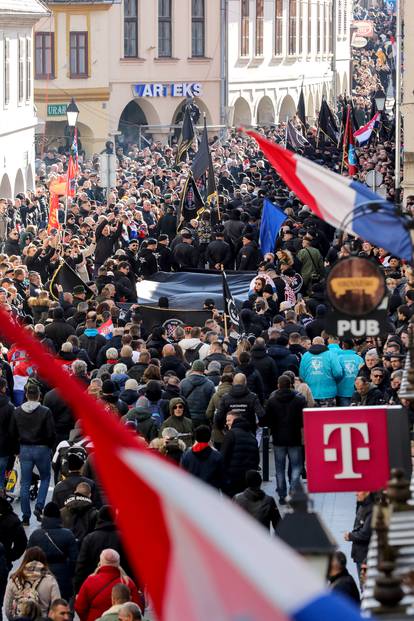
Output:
[{"left": 0, "top": 0, "right": 408, "bottom": 621}]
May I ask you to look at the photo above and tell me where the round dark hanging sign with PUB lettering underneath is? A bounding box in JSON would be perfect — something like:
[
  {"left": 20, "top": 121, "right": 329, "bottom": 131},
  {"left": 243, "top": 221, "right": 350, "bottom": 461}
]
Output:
[{"left": 326, "top": 257, "right": 387, "bottom": 337}]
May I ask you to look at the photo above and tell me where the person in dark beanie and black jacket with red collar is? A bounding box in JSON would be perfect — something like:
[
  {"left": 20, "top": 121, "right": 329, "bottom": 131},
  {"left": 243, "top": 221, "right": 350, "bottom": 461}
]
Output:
[{"left": 181, "top": 425, "right": 223, "bottom": 489}]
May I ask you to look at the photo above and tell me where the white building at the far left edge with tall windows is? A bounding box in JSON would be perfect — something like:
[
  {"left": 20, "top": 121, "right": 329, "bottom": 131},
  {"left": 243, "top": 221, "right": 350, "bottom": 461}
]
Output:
[{"left": 0, "top": 0, "right": 48, "bottom": 198}]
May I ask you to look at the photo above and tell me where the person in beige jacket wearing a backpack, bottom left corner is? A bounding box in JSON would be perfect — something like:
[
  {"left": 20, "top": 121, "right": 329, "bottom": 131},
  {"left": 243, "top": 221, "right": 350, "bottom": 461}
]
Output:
[{"left": 4, "top": 546, "right": 60, "bottom": 621}]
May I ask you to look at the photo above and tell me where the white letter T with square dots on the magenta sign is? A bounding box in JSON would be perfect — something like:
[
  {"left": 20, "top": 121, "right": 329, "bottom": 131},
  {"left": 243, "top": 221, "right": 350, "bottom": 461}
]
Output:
[{"left": 323, "top": 423, "right": 370, "bottom": 479}]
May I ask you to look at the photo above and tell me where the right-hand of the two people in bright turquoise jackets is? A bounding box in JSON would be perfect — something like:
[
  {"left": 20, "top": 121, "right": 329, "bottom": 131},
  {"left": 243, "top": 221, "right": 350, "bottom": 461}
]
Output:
[{"left": 328, "top": 336, "right": 364, "bottom": 407}]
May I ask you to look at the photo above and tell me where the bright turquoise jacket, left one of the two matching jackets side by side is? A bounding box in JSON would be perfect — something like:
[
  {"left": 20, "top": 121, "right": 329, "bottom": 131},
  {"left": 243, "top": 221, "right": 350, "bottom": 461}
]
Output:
[{"left": 299, "top": 345, "right": 344, "bottom": 399}]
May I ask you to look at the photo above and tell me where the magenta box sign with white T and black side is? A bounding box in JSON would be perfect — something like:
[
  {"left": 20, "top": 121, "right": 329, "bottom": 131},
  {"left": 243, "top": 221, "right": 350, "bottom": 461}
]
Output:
[{"left": 304, "top": 406, "right": 411, "bottom": 492}]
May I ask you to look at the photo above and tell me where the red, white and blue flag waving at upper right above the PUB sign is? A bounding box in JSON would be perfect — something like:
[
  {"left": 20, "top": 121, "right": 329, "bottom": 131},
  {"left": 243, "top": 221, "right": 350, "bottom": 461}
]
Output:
[{"left": 246, "top": 131, "right": 412, "bottom": 261}]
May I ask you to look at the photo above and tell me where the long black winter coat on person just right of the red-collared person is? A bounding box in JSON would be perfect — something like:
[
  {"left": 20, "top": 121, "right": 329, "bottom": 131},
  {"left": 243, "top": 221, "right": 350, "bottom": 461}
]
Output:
[{"left": 221, "top": 417, "right": 260, "bottom": 496}]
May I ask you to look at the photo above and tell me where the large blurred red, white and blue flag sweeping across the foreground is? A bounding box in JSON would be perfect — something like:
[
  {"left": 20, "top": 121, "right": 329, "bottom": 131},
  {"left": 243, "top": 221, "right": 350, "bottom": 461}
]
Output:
[{"left": 0, "top": 309, "right": 361, "bottom": 621}]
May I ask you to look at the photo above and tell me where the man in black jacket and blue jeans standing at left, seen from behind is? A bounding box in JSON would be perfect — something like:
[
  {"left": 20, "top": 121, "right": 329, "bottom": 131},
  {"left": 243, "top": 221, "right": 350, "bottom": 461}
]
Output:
[{"left": 10, "top": 383, "right": 56, "bottom": 526}]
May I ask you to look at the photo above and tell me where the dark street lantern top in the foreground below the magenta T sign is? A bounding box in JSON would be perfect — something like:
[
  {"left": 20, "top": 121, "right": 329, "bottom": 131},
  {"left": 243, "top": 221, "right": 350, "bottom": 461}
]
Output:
[{"left": 276, "top": 483, "right": 338, "bottom": 581}]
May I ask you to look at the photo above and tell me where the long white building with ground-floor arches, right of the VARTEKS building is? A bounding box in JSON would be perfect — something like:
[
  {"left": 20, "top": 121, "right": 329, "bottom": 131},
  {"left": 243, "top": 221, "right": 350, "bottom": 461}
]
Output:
[{"left": 228, "top": 0, "right": 352, "bottom": 125}]
